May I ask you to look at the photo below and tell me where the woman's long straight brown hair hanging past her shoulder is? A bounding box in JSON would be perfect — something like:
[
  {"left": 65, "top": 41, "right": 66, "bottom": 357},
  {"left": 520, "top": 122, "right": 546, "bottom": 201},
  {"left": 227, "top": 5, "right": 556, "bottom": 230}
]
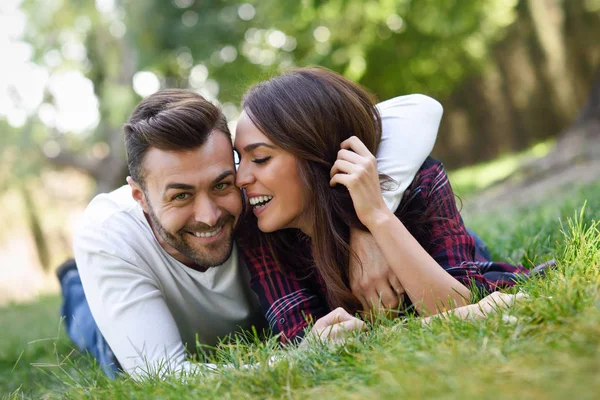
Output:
[{"left": 242, "top": 68, "right": 381, "bottom": 312}]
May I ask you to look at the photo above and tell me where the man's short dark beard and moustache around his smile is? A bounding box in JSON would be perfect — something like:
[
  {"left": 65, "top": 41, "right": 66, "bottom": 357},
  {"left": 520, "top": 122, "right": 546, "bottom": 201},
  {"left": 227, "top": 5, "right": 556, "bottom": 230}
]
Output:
[{"left": 148, "top": 204, "right": 235, "bottom": 267}]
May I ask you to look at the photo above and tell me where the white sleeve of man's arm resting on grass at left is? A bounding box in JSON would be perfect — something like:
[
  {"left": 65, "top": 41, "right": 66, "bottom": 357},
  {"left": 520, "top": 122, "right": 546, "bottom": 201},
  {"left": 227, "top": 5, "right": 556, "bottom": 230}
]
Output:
[{"left": 74, "top": 228, "right": 198, "bottom": 378}]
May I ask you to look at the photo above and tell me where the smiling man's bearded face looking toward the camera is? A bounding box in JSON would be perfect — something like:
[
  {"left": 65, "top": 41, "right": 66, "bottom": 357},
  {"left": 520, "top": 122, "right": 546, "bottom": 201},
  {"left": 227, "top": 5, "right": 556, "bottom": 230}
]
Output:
[{"left": 129, "top": 131, "right": 242, "bottom": 267}]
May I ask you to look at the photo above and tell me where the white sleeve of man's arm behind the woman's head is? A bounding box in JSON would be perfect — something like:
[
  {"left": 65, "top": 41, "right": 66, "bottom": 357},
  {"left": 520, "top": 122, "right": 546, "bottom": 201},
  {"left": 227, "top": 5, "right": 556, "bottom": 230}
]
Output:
[{"left": 376, "top": 94, "right": 444, "bottom": 211}]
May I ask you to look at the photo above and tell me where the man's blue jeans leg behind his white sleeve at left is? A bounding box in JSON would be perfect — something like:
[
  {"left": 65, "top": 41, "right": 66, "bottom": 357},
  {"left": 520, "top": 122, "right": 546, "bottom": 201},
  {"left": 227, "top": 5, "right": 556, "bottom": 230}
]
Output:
[{"left": 59, "top": 262, "right": 119, "bottom": 378}]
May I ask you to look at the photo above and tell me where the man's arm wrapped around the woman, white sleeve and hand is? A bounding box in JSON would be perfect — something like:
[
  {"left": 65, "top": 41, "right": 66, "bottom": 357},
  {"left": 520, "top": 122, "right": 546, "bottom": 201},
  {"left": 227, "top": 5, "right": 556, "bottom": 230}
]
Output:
[{"left": 349, "top": 94, "right": 443, "bottom": 310}]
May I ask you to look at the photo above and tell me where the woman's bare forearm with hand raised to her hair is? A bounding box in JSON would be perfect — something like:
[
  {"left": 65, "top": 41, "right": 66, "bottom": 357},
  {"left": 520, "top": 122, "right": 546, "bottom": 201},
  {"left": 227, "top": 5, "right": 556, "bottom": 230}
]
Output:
[{"left": 331, "top": 137, "right": 470, "bottom": 315}]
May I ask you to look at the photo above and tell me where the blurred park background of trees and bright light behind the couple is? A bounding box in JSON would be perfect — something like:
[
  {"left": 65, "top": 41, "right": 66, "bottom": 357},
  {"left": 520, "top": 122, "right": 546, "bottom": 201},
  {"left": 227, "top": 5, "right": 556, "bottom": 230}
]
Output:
[{"left": 0, "top": 0, "right": 600, "bottom": 303}]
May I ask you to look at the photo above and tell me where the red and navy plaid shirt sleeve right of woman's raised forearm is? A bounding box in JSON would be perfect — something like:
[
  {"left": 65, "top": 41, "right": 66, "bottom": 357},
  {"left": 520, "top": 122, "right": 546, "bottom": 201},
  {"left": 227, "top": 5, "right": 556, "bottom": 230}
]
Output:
[{"left": 426, "top": 164, "right": 528, "bottom": 296}]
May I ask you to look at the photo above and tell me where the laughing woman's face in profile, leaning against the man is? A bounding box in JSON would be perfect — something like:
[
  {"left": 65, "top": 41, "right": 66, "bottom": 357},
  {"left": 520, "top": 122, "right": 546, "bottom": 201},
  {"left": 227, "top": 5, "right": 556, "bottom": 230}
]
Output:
[{"left": 234, "top": 111, "right": 311, "bottom": 236}]
